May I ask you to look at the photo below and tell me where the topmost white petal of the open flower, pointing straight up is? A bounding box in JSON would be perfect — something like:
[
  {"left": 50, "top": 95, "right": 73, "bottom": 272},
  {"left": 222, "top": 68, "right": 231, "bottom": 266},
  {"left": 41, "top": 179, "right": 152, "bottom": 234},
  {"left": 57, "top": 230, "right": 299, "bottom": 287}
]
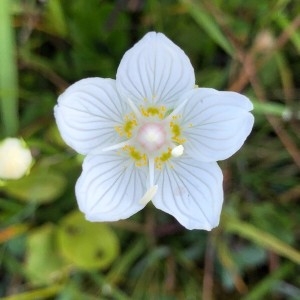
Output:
[{"left": 116, "top": 32, "right": 195, "bottom": 105}]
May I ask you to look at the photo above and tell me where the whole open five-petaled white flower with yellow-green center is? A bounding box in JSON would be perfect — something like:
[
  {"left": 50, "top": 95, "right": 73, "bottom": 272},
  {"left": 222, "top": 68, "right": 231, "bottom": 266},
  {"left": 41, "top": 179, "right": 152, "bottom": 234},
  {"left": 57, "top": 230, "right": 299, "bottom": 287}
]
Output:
[{"left": 55, "top": 32, "right": 254, "bottom": 230}]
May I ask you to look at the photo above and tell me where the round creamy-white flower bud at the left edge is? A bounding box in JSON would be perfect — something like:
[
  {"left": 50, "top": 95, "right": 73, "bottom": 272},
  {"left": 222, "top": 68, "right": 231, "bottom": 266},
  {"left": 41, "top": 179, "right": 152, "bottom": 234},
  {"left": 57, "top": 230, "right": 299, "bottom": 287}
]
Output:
[{"left": 0, "top": 138, "right": 32, "bottom": 179}]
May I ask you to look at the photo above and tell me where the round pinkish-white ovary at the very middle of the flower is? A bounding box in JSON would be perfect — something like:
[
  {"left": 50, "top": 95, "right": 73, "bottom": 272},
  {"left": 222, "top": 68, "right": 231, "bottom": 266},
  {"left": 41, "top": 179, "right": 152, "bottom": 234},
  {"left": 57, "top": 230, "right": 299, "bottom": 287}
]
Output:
[{"left": 137, "top": 123, "right": 166, "bottom": 153}]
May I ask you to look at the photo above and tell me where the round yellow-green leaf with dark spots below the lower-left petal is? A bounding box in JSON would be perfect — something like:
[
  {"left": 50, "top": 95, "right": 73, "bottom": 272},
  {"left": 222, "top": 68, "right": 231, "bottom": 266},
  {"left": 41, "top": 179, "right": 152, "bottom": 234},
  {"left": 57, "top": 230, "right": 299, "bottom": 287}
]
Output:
[{"left": 57, "top": 211, "right": 119, "bottom": 269}]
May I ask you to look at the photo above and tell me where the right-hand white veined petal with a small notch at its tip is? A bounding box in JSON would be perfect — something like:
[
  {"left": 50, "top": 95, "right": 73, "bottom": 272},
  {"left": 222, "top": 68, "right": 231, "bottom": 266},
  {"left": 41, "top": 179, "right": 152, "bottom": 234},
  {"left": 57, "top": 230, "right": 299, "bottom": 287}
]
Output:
[{"left": 181, "top": 88, "right": 254, "bottom": 162}]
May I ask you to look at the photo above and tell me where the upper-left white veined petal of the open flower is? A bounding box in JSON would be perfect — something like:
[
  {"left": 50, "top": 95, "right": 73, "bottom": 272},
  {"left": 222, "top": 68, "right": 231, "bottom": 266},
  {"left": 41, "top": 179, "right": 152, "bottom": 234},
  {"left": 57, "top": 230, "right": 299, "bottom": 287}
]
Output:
[{"left": 54, "top": 78, "right": 128, "bottom": 154}]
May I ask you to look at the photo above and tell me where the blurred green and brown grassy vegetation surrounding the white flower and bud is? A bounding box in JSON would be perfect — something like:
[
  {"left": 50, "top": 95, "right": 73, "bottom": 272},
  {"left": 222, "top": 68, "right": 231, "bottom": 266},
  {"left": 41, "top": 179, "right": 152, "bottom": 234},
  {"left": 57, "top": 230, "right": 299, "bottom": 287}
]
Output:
[{"left": 0, "top": 0, "right": 300, "bottom": 300}]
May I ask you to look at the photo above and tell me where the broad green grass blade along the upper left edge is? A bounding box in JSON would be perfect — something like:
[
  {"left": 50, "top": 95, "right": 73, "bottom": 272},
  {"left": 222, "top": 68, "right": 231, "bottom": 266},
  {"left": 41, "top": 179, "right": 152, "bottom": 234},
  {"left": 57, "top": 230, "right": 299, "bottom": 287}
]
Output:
[{"left": 0, "top": 0, "right": 19, "bottom": 136}]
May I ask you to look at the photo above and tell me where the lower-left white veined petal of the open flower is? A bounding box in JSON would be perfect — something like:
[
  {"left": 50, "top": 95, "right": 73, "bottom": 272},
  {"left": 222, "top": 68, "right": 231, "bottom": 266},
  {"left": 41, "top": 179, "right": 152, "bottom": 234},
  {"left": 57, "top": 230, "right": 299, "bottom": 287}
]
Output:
[{"left": 75, "top": 152, "right": 147, "bottom": 221}]
